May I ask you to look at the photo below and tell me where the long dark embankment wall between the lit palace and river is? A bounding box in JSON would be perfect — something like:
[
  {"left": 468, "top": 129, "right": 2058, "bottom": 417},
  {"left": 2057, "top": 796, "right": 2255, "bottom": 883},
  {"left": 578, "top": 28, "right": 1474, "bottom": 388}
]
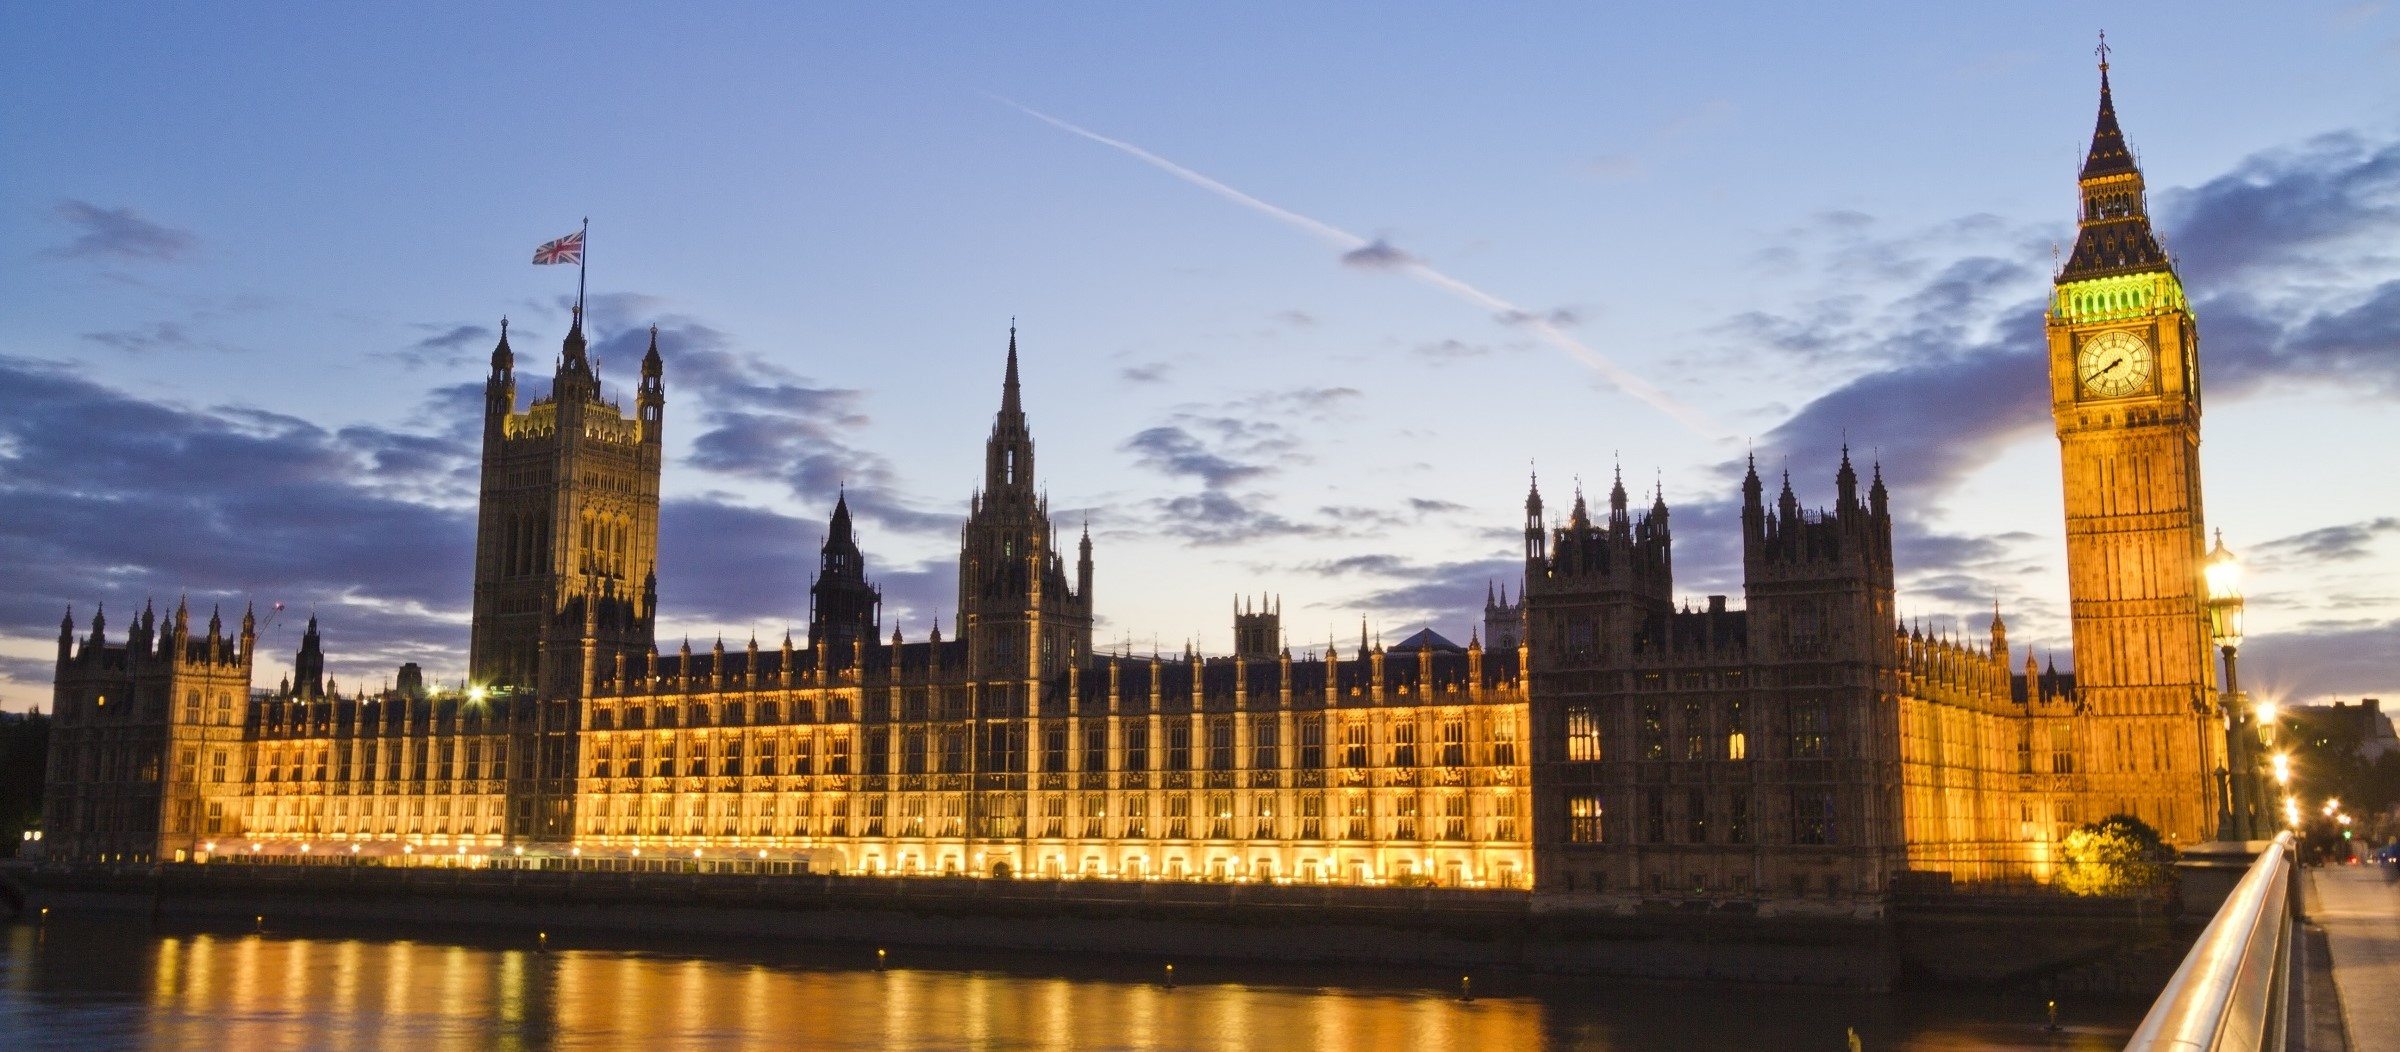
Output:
[{"left": 7, "top": 862, "right": 2191, "bottom": 997}]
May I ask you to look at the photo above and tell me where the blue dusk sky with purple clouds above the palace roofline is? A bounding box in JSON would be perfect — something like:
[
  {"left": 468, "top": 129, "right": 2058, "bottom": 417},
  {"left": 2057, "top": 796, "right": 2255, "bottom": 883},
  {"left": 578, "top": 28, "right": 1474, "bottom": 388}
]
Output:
[{"left": 0, "top": 2, "right": 2400, "bottom": 709}]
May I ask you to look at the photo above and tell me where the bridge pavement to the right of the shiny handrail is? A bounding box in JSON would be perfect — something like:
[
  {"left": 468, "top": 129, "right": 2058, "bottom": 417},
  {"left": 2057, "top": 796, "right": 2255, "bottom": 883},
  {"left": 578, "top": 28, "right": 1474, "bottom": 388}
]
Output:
[{"left": 2306, "top": 865, "right": 2400, "bottom": 1052}]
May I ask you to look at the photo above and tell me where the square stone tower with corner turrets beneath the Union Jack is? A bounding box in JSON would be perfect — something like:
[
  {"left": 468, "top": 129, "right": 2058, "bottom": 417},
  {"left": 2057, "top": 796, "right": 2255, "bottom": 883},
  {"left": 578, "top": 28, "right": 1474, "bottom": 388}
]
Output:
[{"left": 468, "top": 307, "right": 667, "bottom": 697}]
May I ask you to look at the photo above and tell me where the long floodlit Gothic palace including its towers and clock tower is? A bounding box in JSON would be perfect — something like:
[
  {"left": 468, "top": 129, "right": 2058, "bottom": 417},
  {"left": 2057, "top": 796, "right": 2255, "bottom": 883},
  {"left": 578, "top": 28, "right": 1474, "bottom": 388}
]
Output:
[{"left": 43, "top": 65, "right": 2222, "bottom": 910}]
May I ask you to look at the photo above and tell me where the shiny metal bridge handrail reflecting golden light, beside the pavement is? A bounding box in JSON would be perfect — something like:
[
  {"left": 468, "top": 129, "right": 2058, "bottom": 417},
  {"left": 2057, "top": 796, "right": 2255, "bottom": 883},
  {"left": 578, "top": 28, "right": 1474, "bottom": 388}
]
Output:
[{"left": 2124, "top": 833, "right": 2294, "bottom": 1052}]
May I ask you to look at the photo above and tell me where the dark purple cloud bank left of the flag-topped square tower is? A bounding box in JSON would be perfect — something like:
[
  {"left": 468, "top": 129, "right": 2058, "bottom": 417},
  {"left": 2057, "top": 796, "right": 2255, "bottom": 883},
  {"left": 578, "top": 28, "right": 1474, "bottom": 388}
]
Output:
[{"left": 0, "top": 358, "right": 473, "bottom": 706}]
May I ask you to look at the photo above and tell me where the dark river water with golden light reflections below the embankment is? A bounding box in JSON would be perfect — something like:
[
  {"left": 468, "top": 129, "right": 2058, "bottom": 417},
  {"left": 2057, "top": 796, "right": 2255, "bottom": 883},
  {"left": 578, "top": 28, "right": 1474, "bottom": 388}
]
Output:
[{"left": 0, "top": 917, "right": 2143, "bottom": 1052}]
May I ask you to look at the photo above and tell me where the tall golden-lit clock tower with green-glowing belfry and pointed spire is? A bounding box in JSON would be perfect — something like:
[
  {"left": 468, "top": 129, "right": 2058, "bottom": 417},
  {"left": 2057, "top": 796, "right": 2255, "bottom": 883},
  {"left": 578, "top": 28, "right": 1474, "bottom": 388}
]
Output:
[{"left": 2047, "top": 43, "right": 2222, "bottom": 843}]
